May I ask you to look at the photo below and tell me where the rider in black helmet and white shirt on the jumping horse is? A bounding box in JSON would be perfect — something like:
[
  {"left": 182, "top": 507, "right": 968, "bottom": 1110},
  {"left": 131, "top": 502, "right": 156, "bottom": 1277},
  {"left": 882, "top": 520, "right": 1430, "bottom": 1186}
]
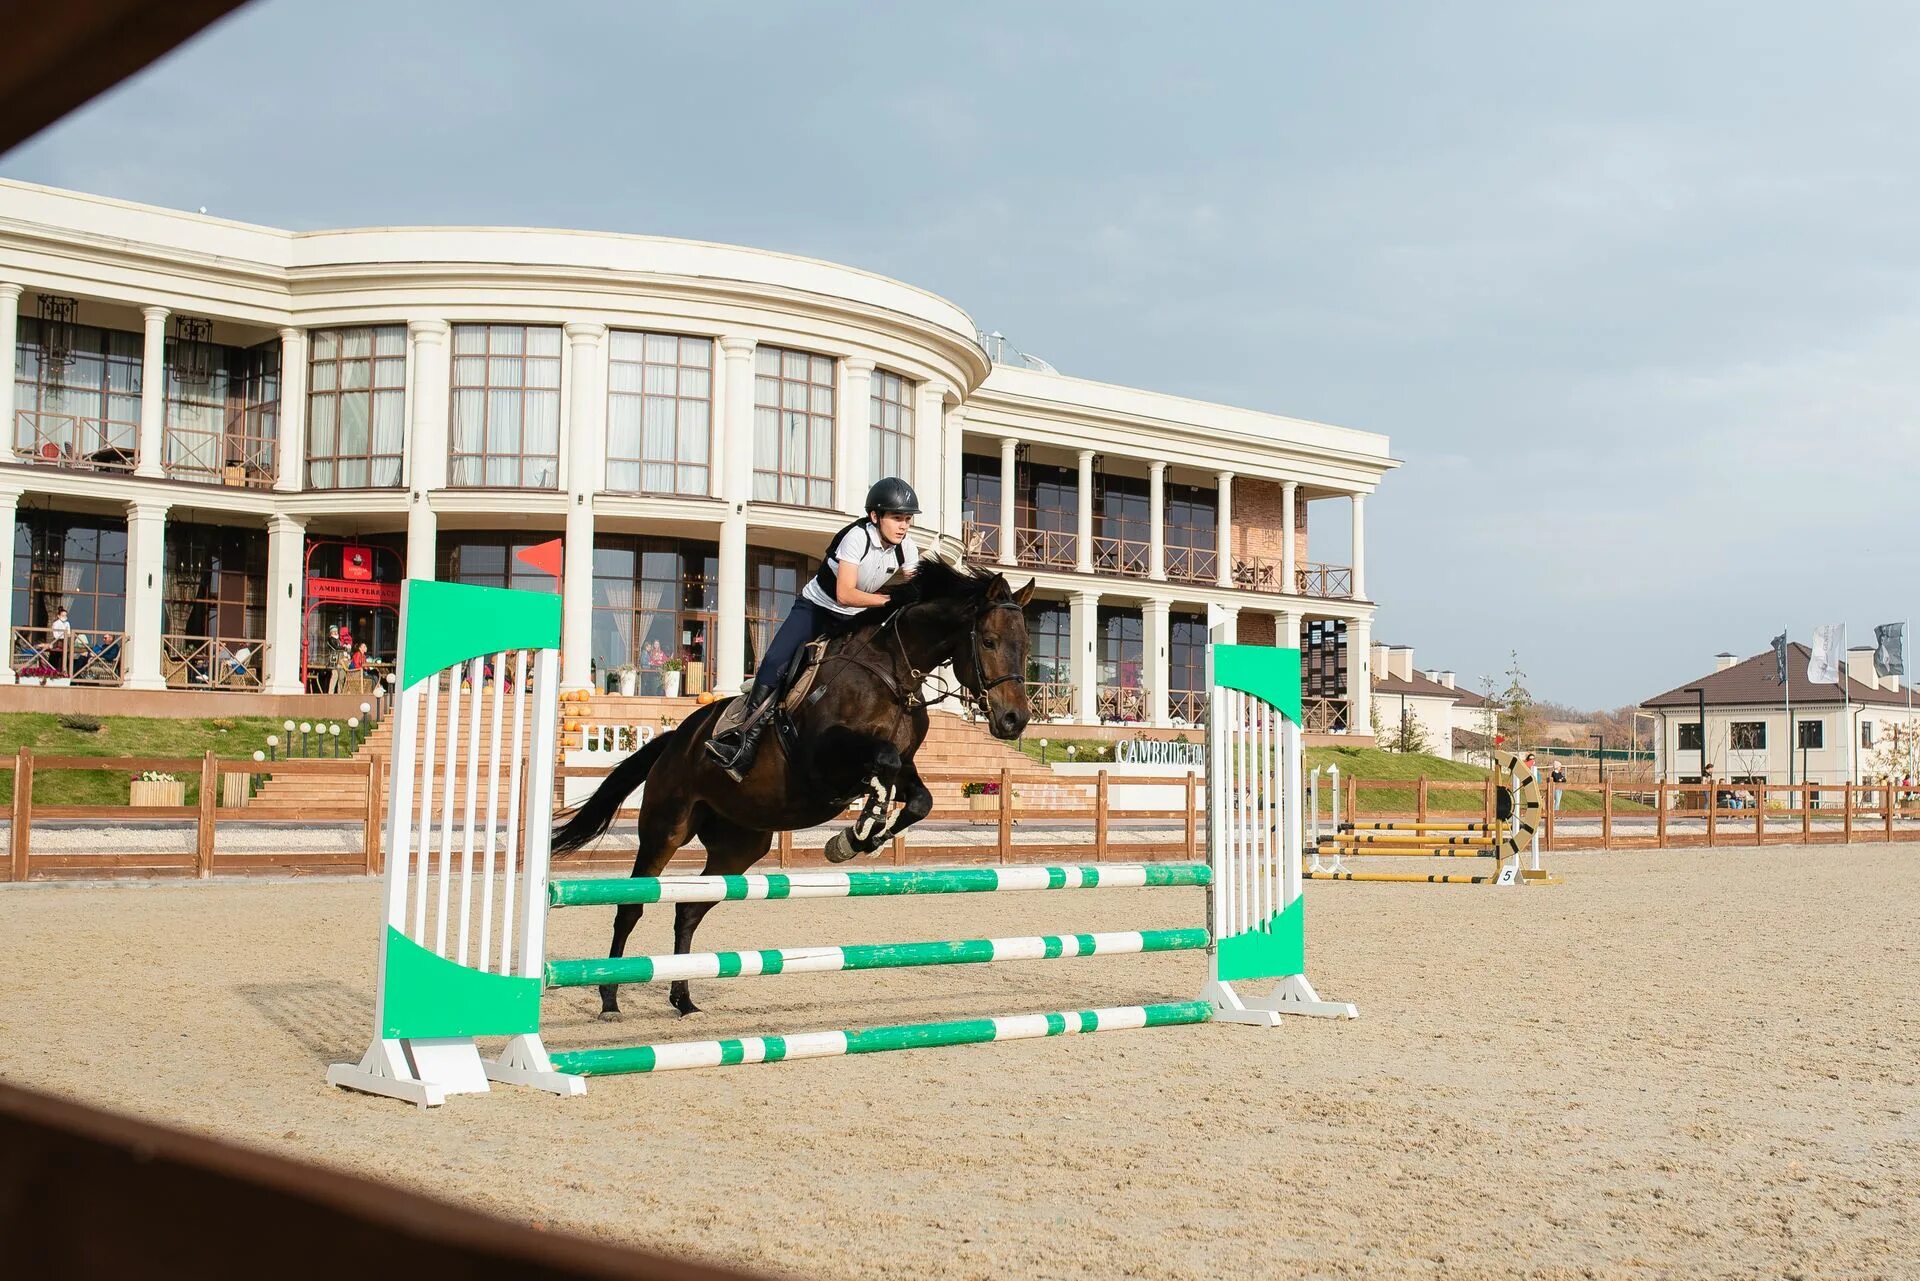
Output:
[{"left": 707, "top": 476, "right": 920, "bottom": 782}]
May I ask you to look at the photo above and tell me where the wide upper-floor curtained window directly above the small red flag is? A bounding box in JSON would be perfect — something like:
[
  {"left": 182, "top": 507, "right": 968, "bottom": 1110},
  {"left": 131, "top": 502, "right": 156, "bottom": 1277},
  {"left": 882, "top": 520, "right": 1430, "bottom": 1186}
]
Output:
[{"left": 447, "top": 325, "right": 561, "bottom": 490}]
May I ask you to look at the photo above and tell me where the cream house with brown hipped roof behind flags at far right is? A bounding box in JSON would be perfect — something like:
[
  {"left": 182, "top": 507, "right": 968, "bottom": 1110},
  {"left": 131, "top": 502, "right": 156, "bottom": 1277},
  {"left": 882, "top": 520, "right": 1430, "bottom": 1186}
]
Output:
[{"left": 1640, "top": 645, "right": 1914, "bottom": 784}]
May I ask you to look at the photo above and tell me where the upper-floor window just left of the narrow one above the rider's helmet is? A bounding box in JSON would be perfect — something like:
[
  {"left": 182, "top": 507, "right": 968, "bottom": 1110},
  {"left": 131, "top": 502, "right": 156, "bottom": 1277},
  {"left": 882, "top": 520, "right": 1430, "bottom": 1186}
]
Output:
[{"left": 753, "top": 348, "right": 833, "bottom": 507}]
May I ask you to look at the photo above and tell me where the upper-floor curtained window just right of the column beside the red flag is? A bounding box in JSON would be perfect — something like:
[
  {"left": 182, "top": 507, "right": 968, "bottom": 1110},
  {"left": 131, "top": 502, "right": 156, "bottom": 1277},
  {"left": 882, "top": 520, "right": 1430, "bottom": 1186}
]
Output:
[{"left": 607, "top": 330, "right": 714, "bottom": 495}]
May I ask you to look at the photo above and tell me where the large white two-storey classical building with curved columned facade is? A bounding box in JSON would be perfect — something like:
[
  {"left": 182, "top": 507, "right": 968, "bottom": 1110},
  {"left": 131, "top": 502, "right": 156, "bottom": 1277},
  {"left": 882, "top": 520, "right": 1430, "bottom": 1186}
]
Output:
[{"left": 0, "top": 182, "right": 1396, "bottom": 734}]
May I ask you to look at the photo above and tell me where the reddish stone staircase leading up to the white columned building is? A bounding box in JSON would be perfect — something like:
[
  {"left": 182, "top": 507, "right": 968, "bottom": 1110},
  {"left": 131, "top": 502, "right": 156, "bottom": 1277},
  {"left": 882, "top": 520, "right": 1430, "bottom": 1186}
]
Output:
[{"left": 252, "top": 693, "right": 1091, "bottom": 818}]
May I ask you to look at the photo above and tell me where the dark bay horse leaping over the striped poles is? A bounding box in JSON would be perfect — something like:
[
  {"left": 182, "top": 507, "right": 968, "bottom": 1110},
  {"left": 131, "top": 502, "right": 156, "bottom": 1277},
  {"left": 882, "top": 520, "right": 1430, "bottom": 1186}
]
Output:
[{"left": 553, "top": 557, "right": 1033, "bottom": 1018}]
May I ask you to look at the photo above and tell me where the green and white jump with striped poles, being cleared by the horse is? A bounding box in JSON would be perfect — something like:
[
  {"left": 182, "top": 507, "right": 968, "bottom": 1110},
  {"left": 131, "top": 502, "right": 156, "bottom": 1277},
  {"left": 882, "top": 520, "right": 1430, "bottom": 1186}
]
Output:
[{"left": 328, "top": 606, "right": 1357, "bottom": 1106}]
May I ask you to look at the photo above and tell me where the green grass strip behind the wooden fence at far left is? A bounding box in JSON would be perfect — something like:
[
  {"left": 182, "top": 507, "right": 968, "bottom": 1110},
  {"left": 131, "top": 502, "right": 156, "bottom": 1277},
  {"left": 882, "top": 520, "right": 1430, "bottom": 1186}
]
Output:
[{"left": 0, "top": 713, "right": 280, "bottom": 805}]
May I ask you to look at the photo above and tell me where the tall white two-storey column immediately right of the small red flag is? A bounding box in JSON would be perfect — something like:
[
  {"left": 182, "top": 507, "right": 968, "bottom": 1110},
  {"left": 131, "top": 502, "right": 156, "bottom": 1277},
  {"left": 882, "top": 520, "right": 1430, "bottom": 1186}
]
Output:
[{"left": 561, "top": 325, "right": 607, "bottom": 691}]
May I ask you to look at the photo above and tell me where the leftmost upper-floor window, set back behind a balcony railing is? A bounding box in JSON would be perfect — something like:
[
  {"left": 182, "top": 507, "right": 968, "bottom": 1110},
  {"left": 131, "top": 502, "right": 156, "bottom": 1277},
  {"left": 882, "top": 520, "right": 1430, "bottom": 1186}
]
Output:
[{"left": 13, "top": 315, "right": 142, "bottom": 471}]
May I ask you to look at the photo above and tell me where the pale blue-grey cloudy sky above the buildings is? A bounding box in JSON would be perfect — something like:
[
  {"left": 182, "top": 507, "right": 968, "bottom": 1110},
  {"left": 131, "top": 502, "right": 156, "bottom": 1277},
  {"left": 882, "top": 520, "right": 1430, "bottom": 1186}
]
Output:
[{"left": 0, "top": 0, "right": 1920, "bottom": 707}]
